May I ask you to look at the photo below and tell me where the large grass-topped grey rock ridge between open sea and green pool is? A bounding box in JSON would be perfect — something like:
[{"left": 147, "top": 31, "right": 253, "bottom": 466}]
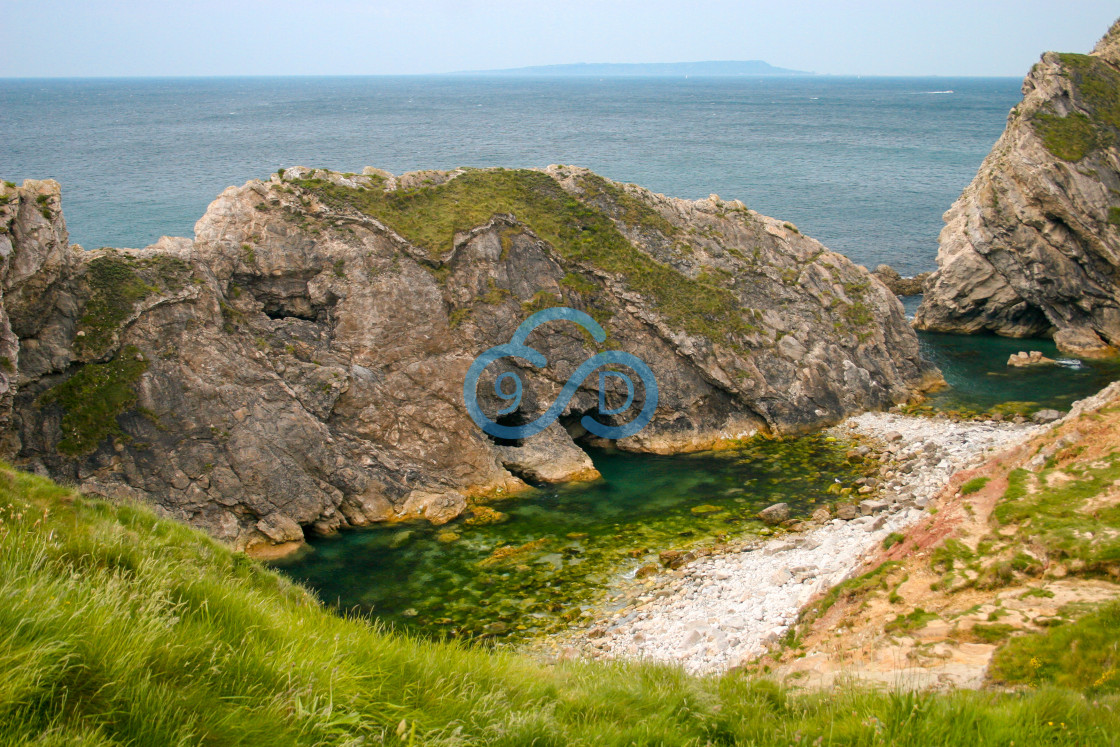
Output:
[{"left": 0, "top": 167, "right": 940, "bottom": 547}]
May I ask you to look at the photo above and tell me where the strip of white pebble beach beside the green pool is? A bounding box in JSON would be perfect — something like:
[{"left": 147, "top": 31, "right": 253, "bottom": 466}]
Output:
[{"left": 568, "top": 412, "right": 1039, "bottom": 673}]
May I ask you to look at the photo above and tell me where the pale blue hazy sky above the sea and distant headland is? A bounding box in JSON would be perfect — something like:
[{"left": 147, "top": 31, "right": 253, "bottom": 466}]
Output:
[{"left": 0, "top": 0, "right": 1120, "bottom": 77}]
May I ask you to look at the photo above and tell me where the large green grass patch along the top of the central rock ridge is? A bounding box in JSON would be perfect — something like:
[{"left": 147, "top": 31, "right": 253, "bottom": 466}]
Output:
[{"left": 291, "top": 169, "right": 757, "bottom": 345}]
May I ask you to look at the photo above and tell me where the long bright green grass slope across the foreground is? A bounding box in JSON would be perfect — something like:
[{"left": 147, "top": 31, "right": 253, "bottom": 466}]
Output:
[{"left": 0, "top": 466, "right": 1120, "bottom": 747}]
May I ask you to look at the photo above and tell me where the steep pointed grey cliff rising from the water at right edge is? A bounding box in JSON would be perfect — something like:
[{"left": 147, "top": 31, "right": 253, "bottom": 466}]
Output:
[{"left": 915, "top": 21, "right": 1120, "bottom": 355}]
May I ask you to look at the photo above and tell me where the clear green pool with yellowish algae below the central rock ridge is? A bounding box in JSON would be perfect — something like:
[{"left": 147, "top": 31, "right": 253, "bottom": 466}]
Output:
[{"left": 268, "top": 436, "right": 864, "bottom": 639}]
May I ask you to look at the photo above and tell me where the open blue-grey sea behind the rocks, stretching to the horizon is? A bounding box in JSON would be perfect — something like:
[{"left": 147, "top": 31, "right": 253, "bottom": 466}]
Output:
[{"left": 0, "top": 75, "right": 1019, "bottom": 274}]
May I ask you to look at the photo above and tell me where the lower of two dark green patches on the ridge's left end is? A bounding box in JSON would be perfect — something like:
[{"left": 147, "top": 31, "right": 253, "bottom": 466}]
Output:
[{"left": 37, "top": 345, "right": 148, "bottom": 456}]
